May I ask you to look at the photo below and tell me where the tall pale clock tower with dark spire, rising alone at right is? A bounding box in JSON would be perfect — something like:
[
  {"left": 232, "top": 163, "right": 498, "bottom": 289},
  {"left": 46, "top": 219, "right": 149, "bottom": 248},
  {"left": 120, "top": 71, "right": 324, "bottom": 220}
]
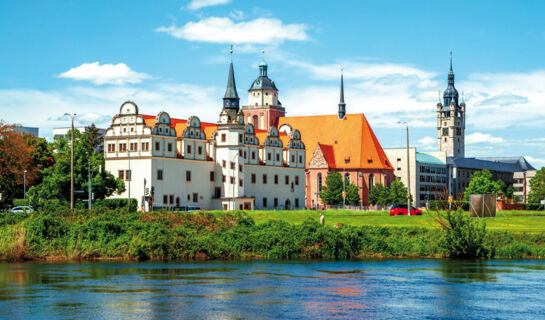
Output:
[{"left": 437, "top": 52, "right": 466, "bottom": 158}]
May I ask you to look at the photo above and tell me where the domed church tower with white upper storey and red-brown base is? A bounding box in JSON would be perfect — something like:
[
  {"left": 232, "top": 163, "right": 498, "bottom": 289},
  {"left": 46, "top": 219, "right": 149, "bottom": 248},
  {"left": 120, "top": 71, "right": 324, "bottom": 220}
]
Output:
[{"left": 242, "top": 55, "right": 286, "bottom": 130}]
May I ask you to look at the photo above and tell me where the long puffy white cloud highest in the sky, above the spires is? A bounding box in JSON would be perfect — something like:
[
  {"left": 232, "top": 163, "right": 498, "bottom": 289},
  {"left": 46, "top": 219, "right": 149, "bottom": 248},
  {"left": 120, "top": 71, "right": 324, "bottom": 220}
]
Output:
[{"left": 156, "top": 17, "right": 308, "bottom": 44}]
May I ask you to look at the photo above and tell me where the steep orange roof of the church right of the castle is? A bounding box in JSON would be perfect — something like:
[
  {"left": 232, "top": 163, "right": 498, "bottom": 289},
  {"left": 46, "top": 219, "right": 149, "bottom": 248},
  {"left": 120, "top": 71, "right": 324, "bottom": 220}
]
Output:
[{"left": 278, "top": 113, "right": 393, "bottom": 170}]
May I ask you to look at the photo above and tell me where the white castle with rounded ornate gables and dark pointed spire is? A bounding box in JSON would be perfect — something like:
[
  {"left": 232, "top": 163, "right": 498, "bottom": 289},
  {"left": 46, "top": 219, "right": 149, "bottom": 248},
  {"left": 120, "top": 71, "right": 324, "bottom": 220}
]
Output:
[{"left": 104, "top": 58, "right": 306, "bottom": 210}]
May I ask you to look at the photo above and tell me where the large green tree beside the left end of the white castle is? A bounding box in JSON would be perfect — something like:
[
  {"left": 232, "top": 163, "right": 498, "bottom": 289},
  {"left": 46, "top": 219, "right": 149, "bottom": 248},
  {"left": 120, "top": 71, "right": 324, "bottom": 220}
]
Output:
[{"left": 29, "top": 130, "right": 125, "bottom": 206}]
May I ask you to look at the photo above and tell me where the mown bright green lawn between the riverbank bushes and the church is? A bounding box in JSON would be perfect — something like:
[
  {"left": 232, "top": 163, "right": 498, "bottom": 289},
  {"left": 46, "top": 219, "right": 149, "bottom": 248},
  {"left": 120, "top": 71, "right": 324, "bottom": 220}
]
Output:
[{"left": 230, "top": 210, "right": 545, "bottom": 233}]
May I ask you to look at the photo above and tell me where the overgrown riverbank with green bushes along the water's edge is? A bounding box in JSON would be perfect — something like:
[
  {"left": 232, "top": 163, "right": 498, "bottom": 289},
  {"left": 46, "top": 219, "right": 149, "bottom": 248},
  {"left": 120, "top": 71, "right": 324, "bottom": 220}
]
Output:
[{"left": 0, "top": 210, "right": 545, "bottom": 261}]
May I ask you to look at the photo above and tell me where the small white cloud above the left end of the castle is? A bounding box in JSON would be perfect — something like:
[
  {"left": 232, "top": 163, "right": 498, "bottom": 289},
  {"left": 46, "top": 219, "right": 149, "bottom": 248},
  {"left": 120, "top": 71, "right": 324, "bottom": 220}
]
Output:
[{"left": 59, "top": 62, "right": 150, "bottom": 85}]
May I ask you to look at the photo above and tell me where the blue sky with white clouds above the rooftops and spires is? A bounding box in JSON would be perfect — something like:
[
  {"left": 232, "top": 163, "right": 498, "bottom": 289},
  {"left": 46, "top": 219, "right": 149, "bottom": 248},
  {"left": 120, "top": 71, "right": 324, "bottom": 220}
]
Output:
[{"left": 0, "top": 0, "right": 545, "bottom": 166}]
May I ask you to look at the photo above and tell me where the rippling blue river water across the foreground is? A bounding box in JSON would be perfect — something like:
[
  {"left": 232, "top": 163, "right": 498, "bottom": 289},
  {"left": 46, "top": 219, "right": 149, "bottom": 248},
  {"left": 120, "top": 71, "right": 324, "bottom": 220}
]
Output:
[{"left": 0, "top": 259, "right": 545, "bottom": 319}]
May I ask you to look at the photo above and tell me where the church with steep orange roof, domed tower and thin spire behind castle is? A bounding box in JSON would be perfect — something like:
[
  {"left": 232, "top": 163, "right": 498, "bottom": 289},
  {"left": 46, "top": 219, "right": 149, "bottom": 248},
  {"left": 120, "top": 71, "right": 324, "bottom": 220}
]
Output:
[{"left": 242, "top": 61, "right": 395, "bottom": 208}]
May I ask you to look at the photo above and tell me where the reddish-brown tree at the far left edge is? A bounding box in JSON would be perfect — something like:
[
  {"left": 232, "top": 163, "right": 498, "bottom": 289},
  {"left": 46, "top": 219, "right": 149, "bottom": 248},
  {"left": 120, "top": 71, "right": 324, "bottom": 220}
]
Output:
[{"left": 0, "top": 121, "right": 39, "bottom": 206}]
